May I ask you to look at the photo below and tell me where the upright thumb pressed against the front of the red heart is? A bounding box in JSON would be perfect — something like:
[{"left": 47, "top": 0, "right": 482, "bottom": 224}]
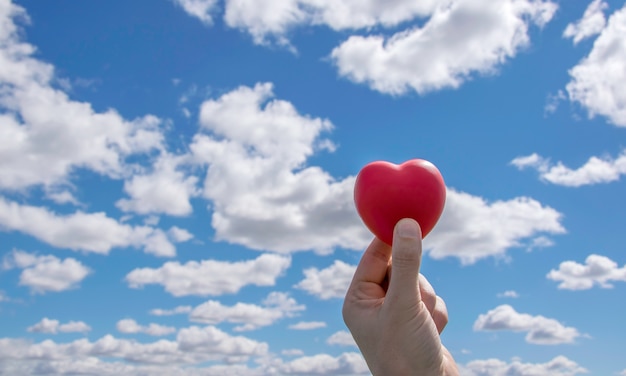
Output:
[{"left": 385, "top": 218, "right": 422, "bottom": 309}]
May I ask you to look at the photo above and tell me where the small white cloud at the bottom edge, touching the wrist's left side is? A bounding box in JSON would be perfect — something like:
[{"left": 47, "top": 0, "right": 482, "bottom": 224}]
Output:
[{"left": 279, "top": 353, "right": 370, "bottom": 375}]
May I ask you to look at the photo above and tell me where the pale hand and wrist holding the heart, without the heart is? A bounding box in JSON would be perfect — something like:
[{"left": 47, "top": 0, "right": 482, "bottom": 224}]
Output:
[{"left": 343, "top": 219, "right": 459, "bottom": 376}]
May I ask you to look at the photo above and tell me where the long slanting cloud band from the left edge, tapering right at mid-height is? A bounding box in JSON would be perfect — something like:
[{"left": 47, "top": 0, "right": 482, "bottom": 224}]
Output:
[{"left": 0, "top": 196, "right": 176, "bottom": 256}]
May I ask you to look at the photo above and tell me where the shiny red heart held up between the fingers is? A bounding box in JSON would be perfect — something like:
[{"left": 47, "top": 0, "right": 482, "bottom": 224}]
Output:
[{"left": 354, "top": 159, "right": 446, "bottom": 244}]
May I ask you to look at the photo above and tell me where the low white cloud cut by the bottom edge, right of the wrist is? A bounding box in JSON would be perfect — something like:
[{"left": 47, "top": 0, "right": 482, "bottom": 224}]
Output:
[{"left": 460, "top": 355, "right": 589, "bottom": 376}]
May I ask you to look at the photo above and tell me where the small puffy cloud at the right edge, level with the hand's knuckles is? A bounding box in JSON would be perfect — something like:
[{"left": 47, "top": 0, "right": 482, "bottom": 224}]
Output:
[{"left": 547, "top": 255, "right": 626, "bottom": 290}]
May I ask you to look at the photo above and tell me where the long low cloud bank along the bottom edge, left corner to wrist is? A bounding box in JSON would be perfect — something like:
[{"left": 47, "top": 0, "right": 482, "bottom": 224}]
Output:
[{"left": 0, "top": 334, "right": 369, "bottom": 376}]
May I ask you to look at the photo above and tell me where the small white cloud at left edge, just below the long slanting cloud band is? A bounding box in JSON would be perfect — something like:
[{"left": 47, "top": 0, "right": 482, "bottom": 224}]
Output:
[{"left": 3, "top": 250, "right": 91, "bottom": 294}]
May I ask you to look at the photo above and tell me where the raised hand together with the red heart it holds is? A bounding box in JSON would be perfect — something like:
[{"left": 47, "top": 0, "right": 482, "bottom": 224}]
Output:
[{"left": 342, "top": 160, "right": 459, "bottom": 376}]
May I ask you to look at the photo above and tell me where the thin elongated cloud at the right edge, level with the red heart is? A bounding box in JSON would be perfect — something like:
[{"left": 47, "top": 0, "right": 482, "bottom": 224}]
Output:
[{"left": 511, "top": 151, "right": 626, "bottom": 187}]
